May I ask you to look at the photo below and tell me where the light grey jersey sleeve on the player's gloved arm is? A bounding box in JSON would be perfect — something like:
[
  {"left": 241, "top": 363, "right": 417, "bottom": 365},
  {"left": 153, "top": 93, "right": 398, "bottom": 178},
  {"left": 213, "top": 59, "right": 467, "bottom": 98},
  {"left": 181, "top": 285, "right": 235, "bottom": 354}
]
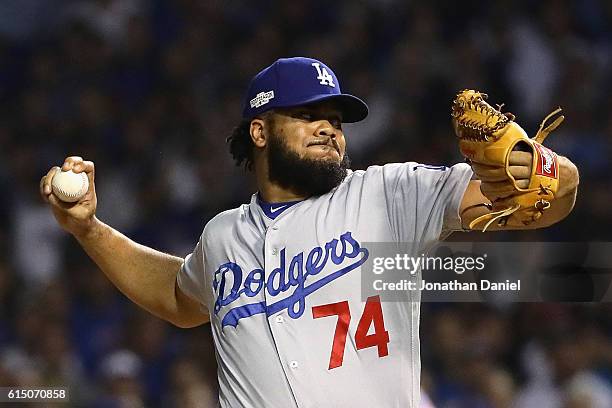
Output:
[{"left": 383, "top": 162, "right": 472, "bottom": 245}]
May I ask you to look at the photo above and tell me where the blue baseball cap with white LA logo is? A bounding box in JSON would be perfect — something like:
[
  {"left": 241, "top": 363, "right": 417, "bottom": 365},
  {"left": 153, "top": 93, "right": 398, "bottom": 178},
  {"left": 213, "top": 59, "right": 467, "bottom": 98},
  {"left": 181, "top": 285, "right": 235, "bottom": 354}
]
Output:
[{"left": 242, "top": 57, "right": 368, "bottom": 123}]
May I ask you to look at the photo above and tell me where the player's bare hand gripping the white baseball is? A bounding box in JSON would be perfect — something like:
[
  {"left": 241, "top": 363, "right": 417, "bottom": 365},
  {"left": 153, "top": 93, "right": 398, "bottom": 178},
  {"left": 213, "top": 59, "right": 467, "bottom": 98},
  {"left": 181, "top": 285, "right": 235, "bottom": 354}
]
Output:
[{"left": 40, "top": 156, "right": 97, "bottom": 236}]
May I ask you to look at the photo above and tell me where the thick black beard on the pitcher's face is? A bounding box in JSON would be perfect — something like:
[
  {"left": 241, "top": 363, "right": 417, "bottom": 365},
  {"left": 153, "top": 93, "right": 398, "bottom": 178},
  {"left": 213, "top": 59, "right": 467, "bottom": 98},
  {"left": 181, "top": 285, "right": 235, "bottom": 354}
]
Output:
[{"left": 268, "top": 135, "right": 351, "bottom": 196}]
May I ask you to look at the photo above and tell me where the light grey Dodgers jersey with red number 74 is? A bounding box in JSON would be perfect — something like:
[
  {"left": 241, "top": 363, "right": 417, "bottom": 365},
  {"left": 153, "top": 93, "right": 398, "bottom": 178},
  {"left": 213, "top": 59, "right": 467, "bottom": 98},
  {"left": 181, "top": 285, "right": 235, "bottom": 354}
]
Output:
[{"left": 177, "top": 162, "right": 472, "bottom": 408}]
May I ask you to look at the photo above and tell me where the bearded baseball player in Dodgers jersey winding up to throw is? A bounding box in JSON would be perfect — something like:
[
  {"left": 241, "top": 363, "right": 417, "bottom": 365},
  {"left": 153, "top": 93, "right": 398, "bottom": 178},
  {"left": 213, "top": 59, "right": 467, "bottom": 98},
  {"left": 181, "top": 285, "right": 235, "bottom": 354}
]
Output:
[{"left": 41, "top": 57, "right": 578, "bottom": 408}]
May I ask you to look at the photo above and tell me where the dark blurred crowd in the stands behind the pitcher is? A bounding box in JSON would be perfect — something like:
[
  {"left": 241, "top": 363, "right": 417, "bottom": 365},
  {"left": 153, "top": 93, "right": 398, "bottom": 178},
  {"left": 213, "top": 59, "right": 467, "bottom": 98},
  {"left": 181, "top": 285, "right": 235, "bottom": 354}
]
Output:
[{"left": 0, "top": 0, "right": 612, "bottom": 408}]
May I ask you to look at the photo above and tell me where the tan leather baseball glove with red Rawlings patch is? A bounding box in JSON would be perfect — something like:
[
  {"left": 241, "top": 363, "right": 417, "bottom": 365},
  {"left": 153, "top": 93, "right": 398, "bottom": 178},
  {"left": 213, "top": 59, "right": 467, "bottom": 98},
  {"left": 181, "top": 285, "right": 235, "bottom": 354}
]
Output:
[{"left": 452, "top": 89, "right": 564, "bottom": 231}]
